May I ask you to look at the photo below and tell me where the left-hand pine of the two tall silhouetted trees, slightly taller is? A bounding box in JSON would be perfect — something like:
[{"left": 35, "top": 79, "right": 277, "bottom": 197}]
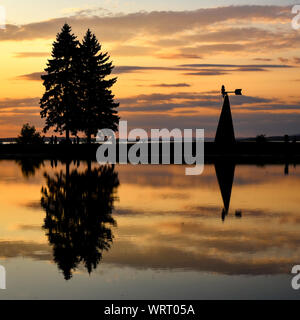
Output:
[{"left": 40, "top": 24, "right": 80, "bottom": 141}]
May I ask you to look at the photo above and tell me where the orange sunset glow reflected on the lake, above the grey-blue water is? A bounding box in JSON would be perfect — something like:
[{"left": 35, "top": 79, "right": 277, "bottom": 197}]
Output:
[{"left": 0, "top": 161, "right": 300, "bottom": 275}]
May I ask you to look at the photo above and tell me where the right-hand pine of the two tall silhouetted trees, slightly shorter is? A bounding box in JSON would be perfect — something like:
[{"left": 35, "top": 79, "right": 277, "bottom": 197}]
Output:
[{"left": 80, "top": 30, "right": 119, "bottom": 143}]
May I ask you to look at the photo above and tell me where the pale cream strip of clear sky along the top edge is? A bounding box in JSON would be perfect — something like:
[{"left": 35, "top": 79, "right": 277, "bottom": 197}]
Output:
[{"left": 0, "top": 0, "right": 299, "bottom": 24}]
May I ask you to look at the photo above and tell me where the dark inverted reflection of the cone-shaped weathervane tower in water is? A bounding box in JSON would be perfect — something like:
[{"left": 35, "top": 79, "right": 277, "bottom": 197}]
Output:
[{"left": 215, "top": 161, "right": 242, "bottom": 221}]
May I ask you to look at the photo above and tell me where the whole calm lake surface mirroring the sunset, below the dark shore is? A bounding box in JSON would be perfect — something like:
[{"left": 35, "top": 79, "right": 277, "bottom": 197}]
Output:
[{"left": 0, "top": 160, "right": 300, "bottom": 299}]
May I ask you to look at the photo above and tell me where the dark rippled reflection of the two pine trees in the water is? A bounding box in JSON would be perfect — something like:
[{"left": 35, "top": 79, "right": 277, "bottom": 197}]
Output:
[{"left": 41, "top": 163, "right": 119, "bottom": 280}]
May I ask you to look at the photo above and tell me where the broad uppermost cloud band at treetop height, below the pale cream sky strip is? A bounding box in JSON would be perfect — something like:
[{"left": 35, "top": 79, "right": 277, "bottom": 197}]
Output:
[{"left": 0, "top": 6, "right": 300, "bottom": 59}]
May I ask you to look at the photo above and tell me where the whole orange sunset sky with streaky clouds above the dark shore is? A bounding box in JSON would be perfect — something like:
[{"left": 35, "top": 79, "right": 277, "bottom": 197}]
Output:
[{"left": 0, "top": 0, "right": 300, "bottom": 137}]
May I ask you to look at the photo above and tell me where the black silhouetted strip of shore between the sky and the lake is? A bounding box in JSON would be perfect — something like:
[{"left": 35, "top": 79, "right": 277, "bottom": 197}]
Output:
[{"left": 0, "top": 142, "right": 300, "bottom": 164}]
